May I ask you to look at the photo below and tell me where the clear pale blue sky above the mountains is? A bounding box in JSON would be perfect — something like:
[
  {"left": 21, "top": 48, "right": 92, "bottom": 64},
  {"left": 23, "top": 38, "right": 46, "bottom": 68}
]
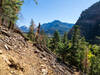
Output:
[{"left": 17, "top": 0, "right": 99, "bottom": 26}]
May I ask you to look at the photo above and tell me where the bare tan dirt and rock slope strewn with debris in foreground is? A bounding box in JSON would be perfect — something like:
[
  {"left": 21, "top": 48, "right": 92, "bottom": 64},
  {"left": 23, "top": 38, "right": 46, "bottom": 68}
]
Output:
[{"left": 0, "top": 27, "right": 73, "bottom": 75}]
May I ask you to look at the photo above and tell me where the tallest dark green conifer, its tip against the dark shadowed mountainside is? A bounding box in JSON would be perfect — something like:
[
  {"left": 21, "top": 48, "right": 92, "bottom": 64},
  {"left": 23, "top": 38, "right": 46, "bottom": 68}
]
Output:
[{"left": 70, "top": 25, "right": 80, "bottom": 66}]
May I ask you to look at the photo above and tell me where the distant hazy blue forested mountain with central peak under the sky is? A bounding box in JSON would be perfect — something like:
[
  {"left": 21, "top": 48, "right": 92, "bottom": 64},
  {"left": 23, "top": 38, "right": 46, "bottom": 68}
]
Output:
[{"left": 41, "top": 20, "right": 74, "bottom": 35}]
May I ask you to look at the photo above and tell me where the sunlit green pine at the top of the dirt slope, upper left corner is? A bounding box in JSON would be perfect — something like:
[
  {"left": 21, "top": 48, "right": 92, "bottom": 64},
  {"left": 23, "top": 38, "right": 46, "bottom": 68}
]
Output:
[{"left": 0, "top": 0, "right": 23, "bottom": 28}]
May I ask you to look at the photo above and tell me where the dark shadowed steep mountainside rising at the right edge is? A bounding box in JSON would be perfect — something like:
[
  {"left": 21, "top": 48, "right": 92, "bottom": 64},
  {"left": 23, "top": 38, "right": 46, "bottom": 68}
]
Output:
[{"left": 68, "top": 1, "right": 100, "bottom": 44}]
